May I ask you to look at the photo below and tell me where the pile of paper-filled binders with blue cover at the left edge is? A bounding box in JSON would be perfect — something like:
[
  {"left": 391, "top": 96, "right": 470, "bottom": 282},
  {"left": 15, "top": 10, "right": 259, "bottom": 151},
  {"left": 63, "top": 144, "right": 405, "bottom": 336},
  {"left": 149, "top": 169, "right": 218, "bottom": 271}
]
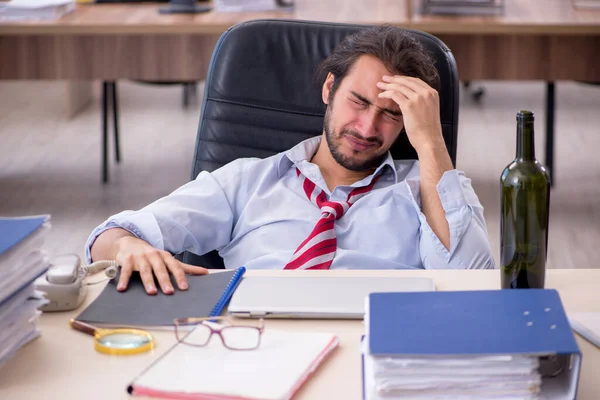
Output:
[{"left": 0, "top": 216, "right": 50, "bottom": 365}]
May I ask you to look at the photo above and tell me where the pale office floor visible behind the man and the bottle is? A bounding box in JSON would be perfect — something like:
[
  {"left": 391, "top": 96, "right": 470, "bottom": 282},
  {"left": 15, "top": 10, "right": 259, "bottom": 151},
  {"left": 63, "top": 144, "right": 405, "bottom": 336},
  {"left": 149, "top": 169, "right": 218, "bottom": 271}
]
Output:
[{"left": 0, "top": 82, "right": 600, "bottom": 268}]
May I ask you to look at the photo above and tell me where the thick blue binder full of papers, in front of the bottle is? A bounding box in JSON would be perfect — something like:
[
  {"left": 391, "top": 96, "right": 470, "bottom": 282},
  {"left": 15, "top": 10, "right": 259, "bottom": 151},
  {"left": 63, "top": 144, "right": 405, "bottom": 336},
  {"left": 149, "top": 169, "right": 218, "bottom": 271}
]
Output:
[{"left": 363, "top": 289, "right": 581, "bottom": 400}]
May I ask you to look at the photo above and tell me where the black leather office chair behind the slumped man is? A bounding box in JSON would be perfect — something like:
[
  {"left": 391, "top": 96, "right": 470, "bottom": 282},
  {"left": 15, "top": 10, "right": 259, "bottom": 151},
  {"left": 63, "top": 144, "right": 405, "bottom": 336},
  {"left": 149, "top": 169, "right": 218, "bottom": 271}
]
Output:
[{"left": 178, "top": 20, "right": 459, "bottom": 268}]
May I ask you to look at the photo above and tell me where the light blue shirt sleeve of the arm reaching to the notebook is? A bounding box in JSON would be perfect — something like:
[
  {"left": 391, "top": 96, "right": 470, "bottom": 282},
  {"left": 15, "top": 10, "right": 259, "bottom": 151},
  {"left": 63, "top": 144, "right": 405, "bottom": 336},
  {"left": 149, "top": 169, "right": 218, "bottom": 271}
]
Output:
[{"left": 85, "top": 161, "right": 253, "bottom": 263}]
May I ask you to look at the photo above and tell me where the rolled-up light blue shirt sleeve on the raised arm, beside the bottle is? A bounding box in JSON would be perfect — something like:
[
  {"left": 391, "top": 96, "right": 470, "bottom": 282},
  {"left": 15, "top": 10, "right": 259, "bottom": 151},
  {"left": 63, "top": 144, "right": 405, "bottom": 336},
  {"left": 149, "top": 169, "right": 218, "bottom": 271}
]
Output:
[{"left": 407, "top": 170, "right": 494, "bottom": 269}]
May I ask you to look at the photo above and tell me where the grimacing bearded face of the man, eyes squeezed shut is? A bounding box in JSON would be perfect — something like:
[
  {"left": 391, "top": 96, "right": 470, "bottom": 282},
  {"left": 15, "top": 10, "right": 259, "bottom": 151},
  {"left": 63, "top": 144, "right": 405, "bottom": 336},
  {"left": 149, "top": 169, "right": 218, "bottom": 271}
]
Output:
[{"left": 323, "top": 56, "right": 404, "bottom": 171}]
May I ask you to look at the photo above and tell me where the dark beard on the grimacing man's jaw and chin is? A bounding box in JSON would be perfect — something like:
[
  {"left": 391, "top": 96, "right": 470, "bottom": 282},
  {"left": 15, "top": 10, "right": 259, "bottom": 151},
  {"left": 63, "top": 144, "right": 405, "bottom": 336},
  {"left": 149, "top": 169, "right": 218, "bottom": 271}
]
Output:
[{"left": 324, "top": 103, "right": 387, "bottom": 172}]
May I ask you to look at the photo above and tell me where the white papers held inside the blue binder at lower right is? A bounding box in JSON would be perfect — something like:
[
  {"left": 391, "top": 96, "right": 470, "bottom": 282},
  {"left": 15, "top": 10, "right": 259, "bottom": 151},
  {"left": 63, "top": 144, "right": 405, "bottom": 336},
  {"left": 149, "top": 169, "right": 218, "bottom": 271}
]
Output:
[{"left": 365, "top": 354, "right": 542, "bottom": 400}]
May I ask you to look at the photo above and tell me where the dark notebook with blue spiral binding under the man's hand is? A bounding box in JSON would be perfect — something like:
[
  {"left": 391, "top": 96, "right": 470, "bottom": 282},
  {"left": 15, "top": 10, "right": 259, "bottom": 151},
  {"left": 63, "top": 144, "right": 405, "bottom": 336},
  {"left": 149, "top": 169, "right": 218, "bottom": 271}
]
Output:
[{"left": 75, "top": 267, "right": 245, "bottom": 329}]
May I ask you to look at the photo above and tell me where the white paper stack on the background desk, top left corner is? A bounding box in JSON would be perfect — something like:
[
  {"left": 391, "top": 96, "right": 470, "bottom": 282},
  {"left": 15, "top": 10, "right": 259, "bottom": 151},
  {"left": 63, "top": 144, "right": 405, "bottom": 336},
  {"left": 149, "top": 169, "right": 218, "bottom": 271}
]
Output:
[{"left": 0, "top": 0, "right": 76, "bottom": 21}]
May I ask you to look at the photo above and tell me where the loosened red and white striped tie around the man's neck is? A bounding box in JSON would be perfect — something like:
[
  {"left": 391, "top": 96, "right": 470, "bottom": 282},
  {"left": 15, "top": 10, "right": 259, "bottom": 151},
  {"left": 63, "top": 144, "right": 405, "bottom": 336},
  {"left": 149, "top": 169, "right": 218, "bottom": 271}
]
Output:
[{"left": 284, "top": 169, "right": 379, "bottom": 269}]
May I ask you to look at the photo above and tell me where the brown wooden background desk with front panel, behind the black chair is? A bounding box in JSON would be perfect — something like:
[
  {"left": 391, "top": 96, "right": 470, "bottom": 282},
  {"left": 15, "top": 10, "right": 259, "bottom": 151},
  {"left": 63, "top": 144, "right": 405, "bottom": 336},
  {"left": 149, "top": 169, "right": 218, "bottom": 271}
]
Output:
[{"left": 0, "top": 0, "right": 600, "bottom": 178}]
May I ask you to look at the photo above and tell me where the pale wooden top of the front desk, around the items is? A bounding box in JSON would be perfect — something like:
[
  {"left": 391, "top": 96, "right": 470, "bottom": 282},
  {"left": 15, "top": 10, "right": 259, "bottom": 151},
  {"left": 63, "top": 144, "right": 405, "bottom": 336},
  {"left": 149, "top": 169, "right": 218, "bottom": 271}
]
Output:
[{"left": 0, "top": 269, "right": 600, "bottom": 400}]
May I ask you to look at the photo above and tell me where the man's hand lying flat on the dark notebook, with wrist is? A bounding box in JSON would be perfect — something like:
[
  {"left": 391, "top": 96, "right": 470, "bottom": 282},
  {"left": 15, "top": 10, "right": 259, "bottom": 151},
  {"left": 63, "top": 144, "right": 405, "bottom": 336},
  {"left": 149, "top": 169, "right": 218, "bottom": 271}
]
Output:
[{"left": 91, "top": 228, "right": 208, "bottom": 295}]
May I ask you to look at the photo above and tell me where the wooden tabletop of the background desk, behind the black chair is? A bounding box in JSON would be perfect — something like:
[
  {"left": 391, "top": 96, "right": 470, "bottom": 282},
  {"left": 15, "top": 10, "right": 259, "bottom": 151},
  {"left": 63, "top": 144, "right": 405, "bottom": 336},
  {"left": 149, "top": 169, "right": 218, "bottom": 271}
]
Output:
[{"left": 0, "top": 0, "right": 600, "bottom": 35}]
